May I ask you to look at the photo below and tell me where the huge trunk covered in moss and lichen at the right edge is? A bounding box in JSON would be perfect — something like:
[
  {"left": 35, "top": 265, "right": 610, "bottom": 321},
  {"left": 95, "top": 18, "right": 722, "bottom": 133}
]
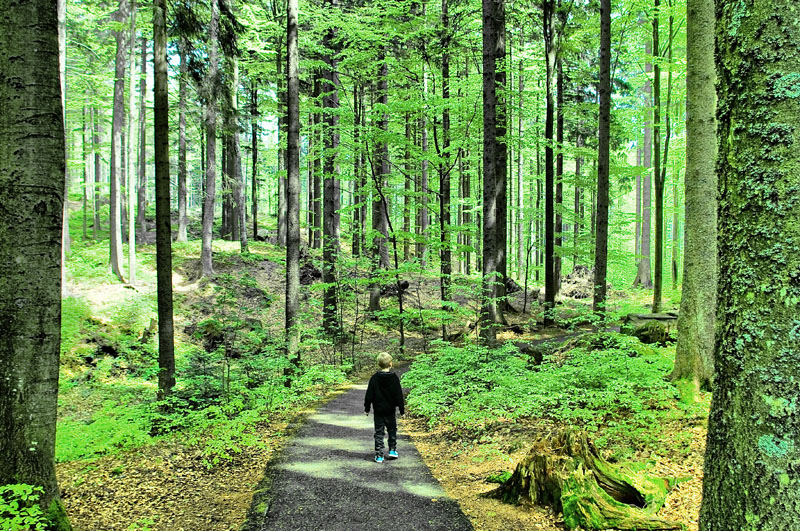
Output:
[{"left": 700, "top": 0, "right": 800, "bottom": 531}]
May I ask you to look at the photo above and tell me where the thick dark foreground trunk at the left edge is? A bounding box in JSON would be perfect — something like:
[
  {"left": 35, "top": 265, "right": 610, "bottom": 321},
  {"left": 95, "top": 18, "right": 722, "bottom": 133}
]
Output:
[{"left": 0, "top": 0, "right": 70, "bottom": 531}]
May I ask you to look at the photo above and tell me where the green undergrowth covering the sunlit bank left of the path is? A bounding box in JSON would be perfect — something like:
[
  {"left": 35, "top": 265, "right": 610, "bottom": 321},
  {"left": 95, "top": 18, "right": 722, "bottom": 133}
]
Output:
[{"left": 61, "top": 222, "right": 347, "bottom": 467}]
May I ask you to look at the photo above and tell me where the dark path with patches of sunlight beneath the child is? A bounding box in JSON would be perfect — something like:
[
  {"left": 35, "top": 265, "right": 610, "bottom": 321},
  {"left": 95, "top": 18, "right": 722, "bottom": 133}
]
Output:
[{"left": 243, "top": 376, "right": 472, "bottom": 531}]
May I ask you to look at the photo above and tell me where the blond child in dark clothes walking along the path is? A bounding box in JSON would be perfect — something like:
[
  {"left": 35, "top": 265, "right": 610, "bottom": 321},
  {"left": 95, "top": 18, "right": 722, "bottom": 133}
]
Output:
[{"left": 364, "top": 352, "right": 405, "bottom": 463}]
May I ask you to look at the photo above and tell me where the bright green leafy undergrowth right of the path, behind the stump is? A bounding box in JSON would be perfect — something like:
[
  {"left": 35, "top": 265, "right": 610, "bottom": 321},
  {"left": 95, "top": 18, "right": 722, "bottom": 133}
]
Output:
[{"left": 403, "top": 333, "right": 695, "bottom": 454}]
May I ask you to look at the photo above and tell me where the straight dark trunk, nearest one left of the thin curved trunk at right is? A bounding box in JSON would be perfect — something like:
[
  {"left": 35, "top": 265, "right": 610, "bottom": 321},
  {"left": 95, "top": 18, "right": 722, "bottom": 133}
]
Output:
[{"left": 592, "top": 0, "right": 611, "bottom": 315}]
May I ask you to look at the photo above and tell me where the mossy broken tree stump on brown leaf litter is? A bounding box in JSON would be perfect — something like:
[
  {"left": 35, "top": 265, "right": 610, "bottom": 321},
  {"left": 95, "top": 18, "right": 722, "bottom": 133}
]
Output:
[{"left": 496, "top": 429, "right": 683, "bottom": 530}]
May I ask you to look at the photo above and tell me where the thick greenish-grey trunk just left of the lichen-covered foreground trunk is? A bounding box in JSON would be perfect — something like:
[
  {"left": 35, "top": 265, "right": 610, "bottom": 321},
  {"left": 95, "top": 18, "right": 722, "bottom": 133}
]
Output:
[{"left": 671, "top": 0, "right": 717, "bottom": 389}]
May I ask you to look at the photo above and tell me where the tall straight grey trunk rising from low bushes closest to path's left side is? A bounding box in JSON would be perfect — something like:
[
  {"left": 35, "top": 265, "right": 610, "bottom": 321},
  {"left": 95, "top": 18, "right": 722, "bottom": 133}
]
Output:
[{"left": 285, "top": 0, "right": 300, "bottom": 363}]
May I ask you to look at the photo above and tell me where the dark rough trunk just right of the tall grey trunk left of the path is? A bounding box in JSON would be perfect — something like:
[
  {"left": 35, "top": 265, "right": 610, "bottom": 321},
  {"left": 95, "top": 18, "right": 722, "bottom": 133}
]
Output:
[{"left": 324, "top": 4, "right": 341, "bottom": 336}]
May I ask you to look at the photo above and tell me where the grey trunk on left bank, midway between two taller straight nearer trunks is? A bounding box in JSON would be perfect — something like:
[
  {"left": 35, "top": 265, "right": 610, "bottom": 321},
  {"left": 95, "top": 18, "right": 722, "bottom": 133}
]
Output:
[{"left": 201, "top": 0, "right": 219, "bottom": 277}]
